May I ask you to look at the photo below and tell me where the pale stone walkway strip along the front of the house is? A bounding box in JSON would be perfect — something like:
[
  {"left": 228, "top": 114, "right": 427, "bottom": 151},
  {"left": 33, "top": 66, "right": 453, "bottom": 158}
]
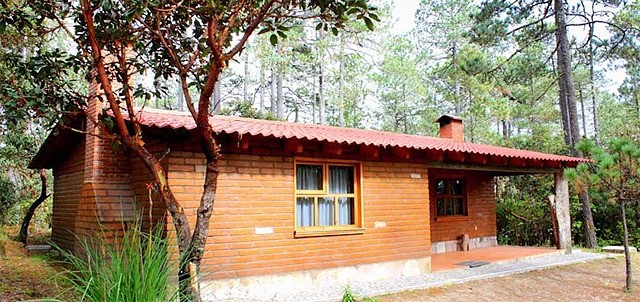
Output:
[{"left": 271, "top": 251, "right": 608, "bottom": 301}]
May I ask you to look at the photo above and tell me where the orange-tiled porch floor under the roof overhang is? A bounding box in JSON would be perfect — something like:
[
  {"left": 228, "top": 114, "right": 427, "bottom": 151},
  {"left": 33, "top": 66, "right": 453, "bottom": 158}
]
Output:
[{"left": 431, "top": 245, "right": 565, "bottom": 272}]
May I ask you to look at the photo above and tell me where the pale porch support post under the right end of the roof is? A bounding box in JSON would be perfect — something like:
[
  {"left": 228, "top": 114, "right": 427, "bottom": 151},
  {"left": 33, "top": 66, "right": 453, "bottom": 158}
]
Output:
[{"left": 554, "top": 172, "right": 571, "bottom": 254}]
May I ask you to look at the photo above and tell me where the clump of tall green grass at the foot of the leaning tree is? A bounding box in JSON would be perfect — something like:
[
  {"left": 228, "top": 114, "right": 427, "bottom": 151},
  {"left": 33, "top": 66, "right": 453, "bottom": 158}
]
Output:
[{"left": 63, "top": 219, "right": 177, "bottom": 302}]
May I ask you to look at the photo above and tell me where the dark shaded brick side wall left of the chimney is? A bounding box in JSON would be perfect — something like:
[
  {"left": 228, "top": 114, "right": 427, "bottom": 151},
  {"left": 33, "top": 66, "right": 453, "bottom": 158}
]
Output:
[{"left": 51, "top": 140, "right": 85, "bottom": 250}]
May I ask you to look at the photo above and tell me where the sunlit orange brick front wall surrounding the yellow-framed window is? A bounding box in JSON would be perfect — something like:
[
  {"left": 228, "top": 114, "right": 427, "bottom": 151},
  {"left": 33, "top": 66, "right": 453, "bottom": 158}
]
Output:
[{"left": 167, "top": 152, "right": 430, "bottom": 278}]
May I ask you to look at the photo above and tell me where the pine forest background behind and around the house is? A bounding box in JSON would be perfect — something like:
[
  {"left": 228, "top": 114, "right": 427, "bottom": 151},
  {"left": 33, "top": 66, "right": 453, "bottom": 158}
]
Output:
[{"left": 0, "top": 0, "right": 640, "bottom": 251}]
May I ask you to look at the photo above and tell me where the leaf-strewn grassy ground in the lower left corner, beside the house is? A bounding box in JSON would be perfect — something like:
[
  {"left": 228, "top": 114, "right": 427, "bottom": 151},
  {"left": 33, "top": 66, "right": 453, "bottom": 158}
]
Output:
[{"left": 0, "top": 229, "right": 78, "bottom": 302}]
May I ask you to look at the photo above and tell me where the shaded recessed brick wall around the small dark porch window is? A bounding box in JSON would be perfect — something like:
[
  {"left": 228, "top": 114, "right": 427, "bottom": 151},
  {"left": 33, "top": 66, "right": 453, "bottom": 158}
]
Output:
[{"left": 429, "top": 169, "right": 497, "bottom": 242}]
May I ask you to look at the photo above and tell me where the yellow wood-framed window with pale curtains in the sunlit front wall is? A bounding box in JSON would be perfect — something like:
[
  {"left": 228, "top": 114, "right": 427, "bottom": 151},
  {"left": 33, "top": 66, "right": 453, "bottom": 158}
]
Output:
[{"left": 295, "top": 160, "right": 361, "bottom": 231}]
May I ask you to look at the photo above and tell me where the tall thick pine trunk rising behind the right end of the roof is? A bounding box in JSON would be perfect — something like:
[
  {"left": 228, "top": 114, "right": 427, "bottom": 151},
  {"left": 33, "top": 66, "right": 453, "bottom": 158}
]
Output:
[{"left": 554, "top": 0, "right": 596, "bottom": 248}]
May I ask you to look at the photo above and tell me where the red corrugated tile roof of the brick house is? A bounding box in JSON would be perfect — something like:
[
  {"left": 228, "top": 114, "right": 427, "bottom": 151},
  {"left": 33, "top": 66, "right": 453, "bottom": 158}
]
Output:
[{"left": 132, "top": 109, "right": 588, "bottom": 166}]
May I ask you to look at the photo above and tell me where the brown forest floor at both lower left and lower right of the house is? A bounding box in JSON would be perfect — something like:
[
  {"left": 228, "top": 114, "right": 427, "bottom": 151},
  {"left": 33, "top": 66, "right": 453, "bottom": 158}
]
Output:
[{"left": 0, "top": 230, "right": 640, "bottom": 302}]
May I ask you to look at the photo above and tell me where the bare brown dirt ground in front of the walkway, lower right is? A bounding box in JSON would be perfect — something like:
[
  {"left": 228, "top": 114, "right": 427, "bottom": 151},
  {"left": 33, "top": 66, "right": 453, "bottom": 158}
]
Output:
[{"left": 375, "top": 254, "right": 640, "bottom": 302}]
